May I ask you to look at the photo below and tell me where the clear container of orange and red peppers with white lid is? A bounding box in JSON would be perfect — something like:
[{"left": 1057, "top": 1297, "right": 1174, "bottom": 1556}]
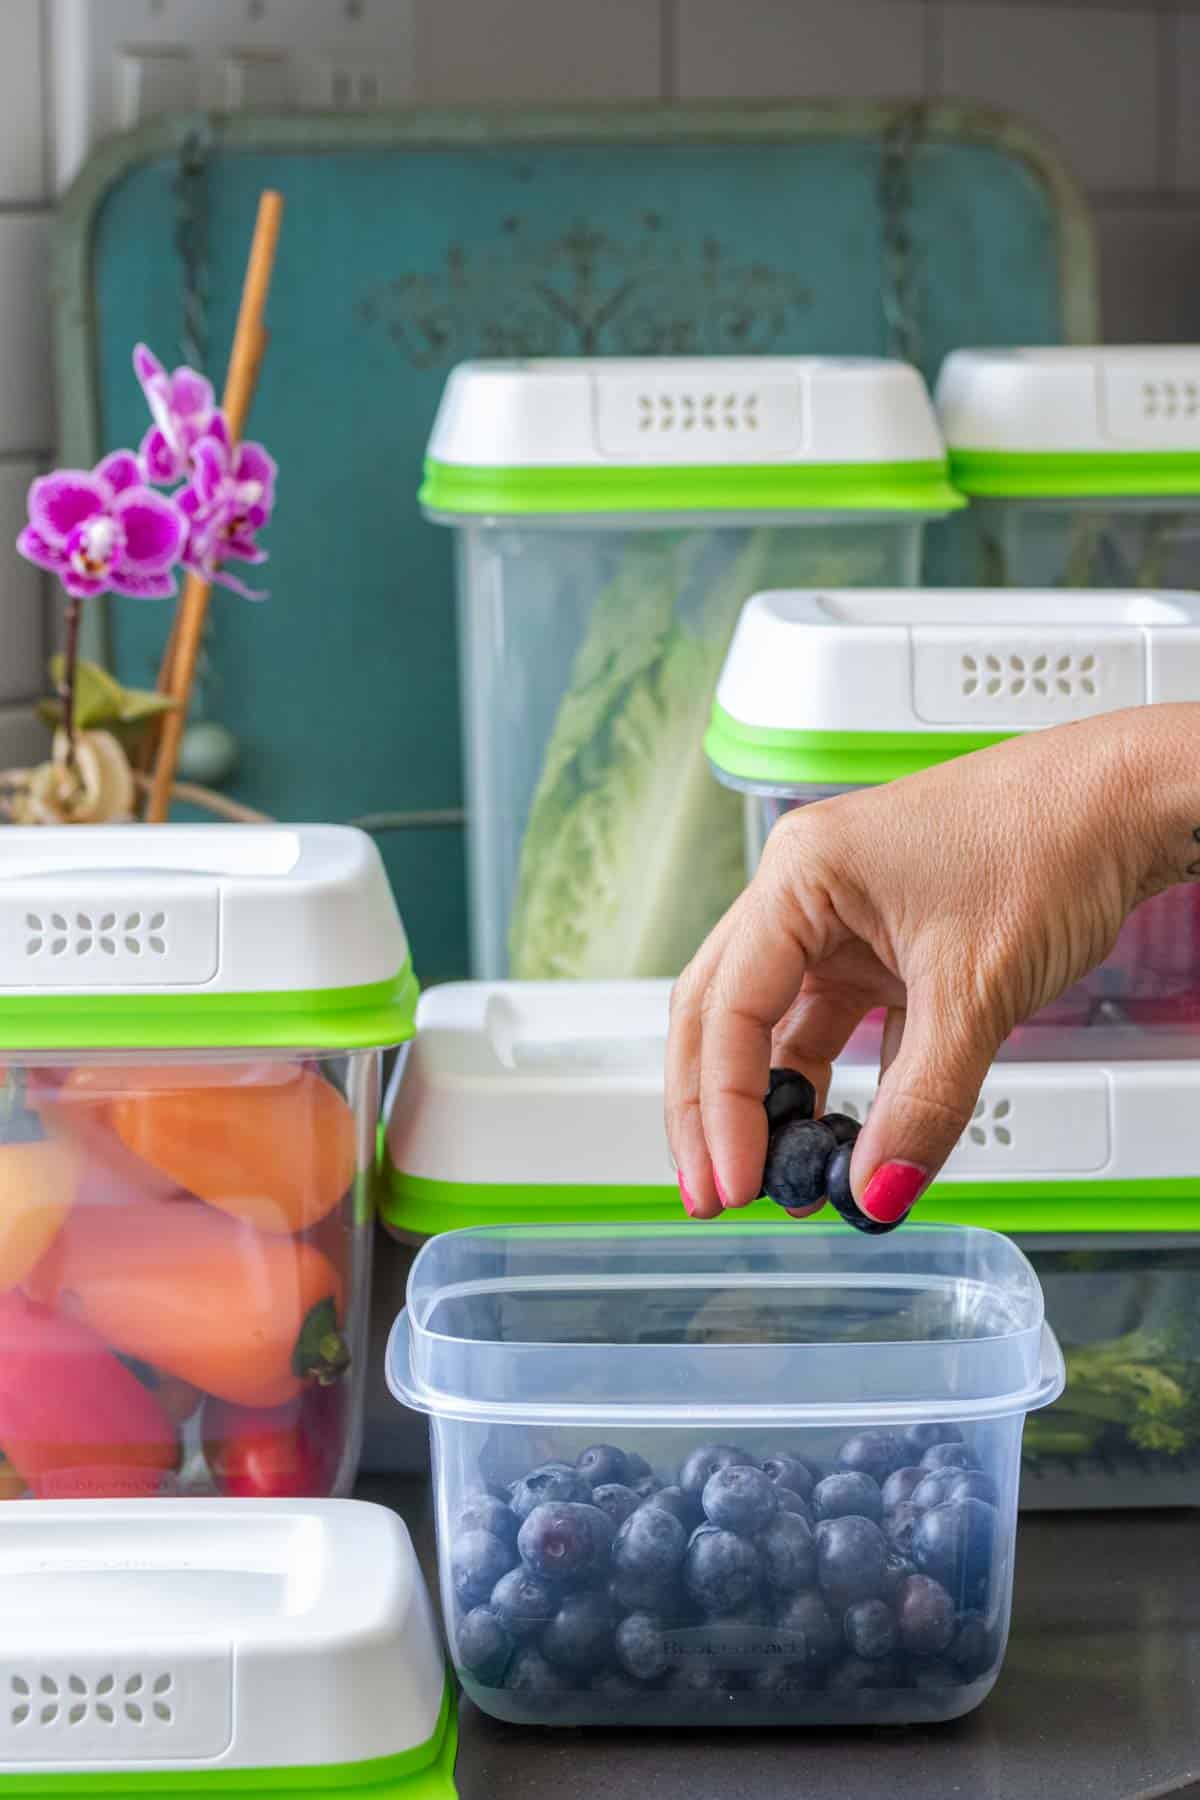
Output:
[{"left": 0, "top": 826, "right": 416, "bottom": 1499}]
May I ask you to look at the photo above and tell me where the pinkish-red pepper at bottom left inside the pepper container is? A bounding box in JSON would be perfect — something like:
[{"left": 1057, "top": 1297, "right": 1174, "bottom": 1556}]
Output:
[{"left": 0, "top": 1292, "right": 180, "bottom": 1499}]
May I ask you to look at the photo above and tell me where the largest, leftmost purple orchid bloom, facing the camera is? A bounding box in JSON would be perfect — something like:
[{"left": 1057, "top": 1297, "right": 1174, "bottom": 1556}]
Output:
[{"left": 16, "top": 450, "right": 187, "bottom": 599}]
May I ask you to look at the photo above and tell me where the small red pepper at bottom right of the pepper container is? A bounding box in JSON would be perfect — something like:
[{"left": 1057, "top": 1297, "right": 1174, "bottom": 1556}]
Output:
[{"left": 203, "top": 1388, "right": 344, "bottom": 1499}]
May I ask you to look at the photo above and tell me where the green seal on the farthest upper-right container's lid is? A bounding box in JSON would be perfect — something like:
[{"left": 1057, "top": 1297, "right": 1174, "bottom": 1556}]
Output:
[{"left": 950, "top": 448, "right": 1200, "bottom": 500}]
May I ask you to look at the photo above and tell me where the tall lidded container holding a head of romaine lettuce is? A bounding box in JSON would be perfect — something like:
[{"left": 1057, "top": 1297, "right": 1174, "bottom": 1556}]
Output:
[{"left": 421, "top": 356, "right": 963, "bottom": 979}]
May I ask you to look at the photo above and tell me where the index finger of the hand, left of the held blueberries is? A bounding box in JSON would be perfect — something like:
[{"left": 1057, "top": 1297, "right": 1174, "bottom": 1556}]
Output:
[{"left": 700, "top": 882, "right": 810, "bottom": 1206}]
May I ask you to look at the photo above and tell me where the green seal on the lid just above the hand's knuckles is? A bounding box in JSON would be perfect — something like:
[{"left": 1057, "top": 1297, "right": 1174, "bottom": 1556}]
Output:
[{"left": 703, "top": 702, "right": 1015, "bottom": 788}]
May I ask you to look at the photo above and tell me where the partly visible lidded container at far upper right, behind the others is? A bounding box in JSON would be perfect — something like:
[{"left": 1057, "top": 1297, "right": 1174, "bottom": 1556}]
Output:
[{"left": 936, "top": 354, "right": 1200, "bottom": 587}]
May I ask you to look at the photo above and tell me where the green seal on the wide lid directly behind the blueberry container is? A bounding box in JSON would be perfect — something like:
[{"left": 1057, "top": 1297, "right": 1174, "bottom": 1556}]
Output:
[{"left": 380, "top": 1168, "right": 1200, "bottom": 1240}]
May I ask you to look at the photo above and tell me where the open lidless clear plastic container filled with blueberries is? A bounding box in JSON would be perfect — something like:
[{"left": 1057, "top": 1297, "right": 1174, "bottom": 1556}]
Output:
[{"left": 389, "top": 1222, "right": 1063, "bottom": 1726}]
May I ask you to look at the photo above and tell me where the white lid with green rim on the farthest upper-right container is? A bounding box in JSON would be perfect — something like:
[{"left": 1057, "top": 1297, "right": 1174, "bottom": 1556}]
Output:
[{"left": 936, "top": 344, "right": 1200, "bottom": 499}]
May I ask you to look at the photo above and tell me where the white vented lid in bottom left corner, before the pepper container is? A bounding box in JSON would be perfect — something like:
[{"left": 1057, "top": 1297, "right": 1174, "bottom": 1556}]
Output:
[{"left": 0, "top": 1499, "right": 453, "bottom": 1796}]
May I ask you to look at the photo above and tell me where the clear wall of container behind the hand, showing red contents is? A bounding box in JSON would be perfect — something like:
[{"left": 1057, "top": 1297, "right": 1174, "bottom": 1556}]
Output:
[{"left": 745, "top": 787, "right": 1200, "bottom": 1033}]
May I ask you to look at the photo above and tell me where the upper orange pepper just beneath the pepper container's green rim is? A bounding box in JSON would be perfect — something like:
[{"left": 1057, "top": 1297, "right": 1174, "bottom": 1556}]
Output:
[{"left": 63, "top": 1062, "right": 358, "bottom": 1233}]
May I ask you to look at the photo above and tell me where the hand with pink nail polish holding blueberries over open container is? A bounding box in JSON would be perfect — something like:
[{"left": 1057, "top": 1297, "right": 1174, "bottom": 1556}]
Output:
[{"left": 666, "top": 706, "right": 1200, "bottom": 1224}]
